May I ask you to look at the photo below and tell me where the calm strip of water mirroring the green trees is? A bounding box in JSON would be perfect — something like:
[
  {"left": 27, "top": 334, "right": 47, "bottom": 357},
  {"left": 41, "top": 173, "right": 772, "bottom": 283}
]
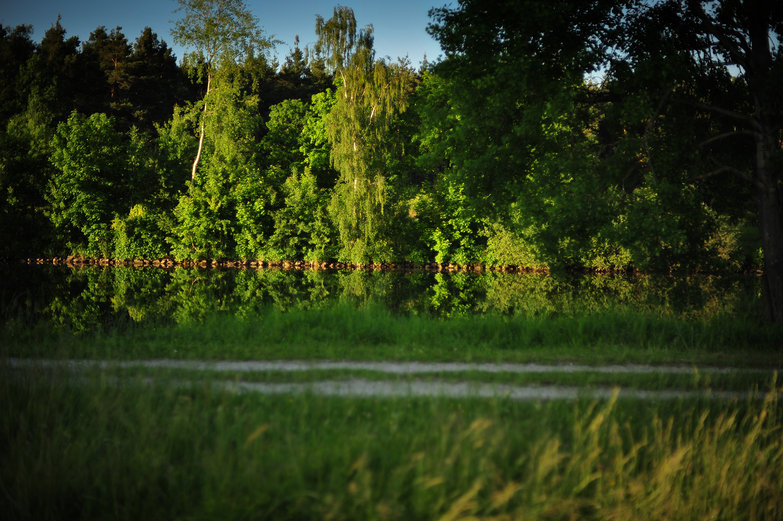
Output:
[{"left": 0, "top": 265, "right": 760, "bottom": 331}]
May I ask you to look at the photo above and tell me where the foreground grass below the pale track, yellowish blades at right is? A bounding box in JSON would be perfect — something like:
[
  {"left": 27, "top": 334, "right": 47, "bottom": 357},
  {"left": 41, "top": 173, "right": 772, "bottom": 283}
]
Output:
[{"left": 0, "top": 366, "right": 783, "bottom": 520}]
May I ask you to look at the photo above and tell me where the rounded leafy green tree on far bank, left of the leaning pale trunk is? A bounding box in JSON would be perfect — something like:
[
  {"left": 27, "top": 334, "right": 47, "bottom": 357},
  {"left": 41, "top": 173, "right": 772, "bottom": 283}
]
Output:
[{"left": 47, "top": 113, "right": 181, "bottom": 259}]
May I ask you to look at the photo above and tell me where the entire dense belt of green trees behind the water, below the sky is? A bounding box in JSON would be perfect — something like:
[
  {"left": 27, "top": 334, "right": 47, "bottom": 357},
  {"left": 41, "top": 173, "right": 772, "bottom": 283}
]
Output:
[{"left": 0, "top": 0, "right": 783, "bottom": 320}]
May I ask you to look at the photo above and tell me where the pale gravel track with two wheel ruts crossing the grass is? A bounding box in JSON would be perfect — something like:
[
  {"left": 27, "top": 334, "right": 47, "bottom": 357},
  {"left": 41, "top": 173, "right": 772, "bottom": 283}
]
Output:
[{"left": 6, "top": 358, "right": 772, "bottom": 401}]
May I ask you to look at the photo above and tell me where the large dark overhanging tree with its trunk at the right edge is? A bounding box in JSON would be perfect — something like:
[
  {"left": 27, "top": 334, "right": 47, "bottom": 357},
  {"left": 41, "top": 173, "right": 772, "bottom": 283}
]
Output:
[{"left": 423, "top": 0, "right": 783, "bottom": 321}]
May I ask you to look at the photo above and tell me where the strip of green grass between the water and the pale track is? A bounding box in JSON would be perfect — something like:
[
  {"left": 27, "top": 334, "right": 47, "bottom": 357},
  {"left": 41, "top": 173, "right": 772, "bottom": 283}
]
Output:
[{"left": 0, "top": 306, "right": 783, "bottom": 368}]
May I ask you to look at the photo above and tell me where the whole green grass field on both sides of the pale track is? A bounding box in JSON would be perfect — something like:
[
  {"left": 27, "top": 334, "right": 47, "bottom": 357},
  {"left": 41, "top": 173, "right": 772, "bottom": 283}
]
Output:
[{"left": 0, "top": 302, "right": 783, "bottom": 520}]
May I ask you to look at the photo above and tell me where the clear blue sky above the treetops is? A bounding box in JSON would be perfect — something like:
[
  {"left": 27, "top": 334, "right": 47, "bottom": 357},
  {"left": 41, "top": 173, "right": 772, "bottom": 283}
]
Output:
[{"left": 0, "top": 0, "right": 456, "bottom": 66}]
